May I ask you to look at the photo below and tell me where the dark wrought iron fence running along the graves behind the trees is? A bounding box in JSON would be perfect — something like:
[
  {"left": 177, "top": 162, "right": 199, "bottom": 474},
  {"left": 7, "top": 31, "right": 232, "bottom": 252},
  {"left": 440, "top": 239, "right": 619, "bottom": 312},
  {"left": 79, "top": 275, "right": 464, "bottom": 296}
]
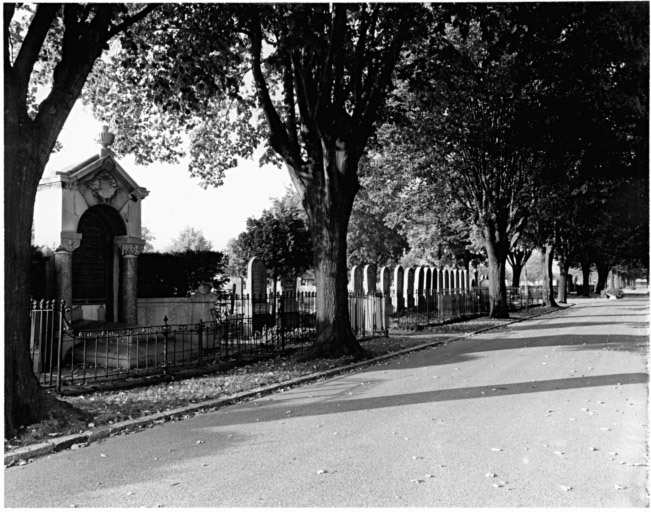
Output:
[{"left": 30, "top": 288, "right": 541, "bottom": 390}]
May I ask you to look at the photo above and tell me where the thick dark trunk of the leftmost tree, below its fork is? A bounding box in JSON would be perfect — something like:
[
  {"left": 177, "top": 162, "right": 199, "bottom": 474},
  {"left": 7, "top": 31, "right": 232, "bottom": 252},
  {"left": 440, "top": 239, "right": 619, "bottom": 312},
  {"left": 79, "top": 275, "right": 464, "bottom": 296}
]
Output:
[{"left": 4, "top": 92, "right": 84, "bottom": 438}]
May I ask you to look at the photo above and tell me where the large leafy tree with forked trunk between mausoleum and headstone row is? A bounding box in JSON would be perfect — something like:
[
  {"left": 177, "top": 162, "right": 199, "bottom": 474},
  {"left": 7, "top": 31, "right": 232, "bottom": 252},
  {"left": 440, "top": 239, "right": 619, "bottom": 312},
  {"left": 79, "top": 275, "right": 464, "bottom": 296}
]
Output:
[{"left": 86, "top": 3, "right": 434, "bottom": 355}]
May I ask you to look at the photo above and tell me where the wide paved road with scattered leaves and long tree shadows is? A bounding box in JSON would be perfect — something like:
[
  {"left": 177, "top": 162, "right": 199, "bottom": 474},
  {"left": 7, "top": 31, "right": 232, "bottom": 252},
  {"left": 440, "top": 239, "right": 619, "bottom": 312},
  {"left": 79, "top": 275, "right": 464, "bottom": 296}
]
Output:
[{"left": 4, "top": 296, "right": 649, "bottom": 508}]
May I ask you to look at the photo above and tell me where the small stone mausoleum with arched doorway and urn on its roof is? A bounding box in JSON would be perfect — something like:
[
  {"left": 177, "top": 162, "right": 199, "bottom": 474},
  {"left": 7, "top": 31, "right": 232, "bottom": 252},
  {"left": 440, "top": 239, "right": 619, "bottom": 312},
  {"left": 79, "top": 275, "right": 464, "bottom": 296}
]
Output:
[{"left": 34, "top": 126, "right": 149, "bottom": 324}]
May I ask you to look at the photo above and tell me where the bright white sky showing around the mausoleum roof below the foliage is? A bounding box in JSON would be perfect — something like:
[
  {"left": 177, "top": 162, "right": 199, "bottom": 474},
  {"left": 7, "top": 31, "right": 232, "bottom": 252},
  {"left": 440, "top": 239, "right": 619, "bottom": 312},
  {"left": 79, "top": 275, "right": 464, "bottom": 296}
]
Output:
[{"left": 46, "top": 102, "right": 291, "bottom": 251}]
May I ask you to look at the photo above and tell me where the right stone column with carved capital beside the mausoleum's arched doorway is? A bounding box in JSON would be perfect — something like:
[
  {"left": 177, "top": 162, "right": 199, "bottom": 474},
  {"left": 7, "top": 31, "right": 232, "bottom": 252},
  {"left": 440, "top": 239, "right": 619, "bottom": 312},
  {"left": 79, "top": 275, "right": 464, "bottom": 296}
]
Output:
[{"left": 115, "top": 236, "right": 145, "bottom": 324}]
